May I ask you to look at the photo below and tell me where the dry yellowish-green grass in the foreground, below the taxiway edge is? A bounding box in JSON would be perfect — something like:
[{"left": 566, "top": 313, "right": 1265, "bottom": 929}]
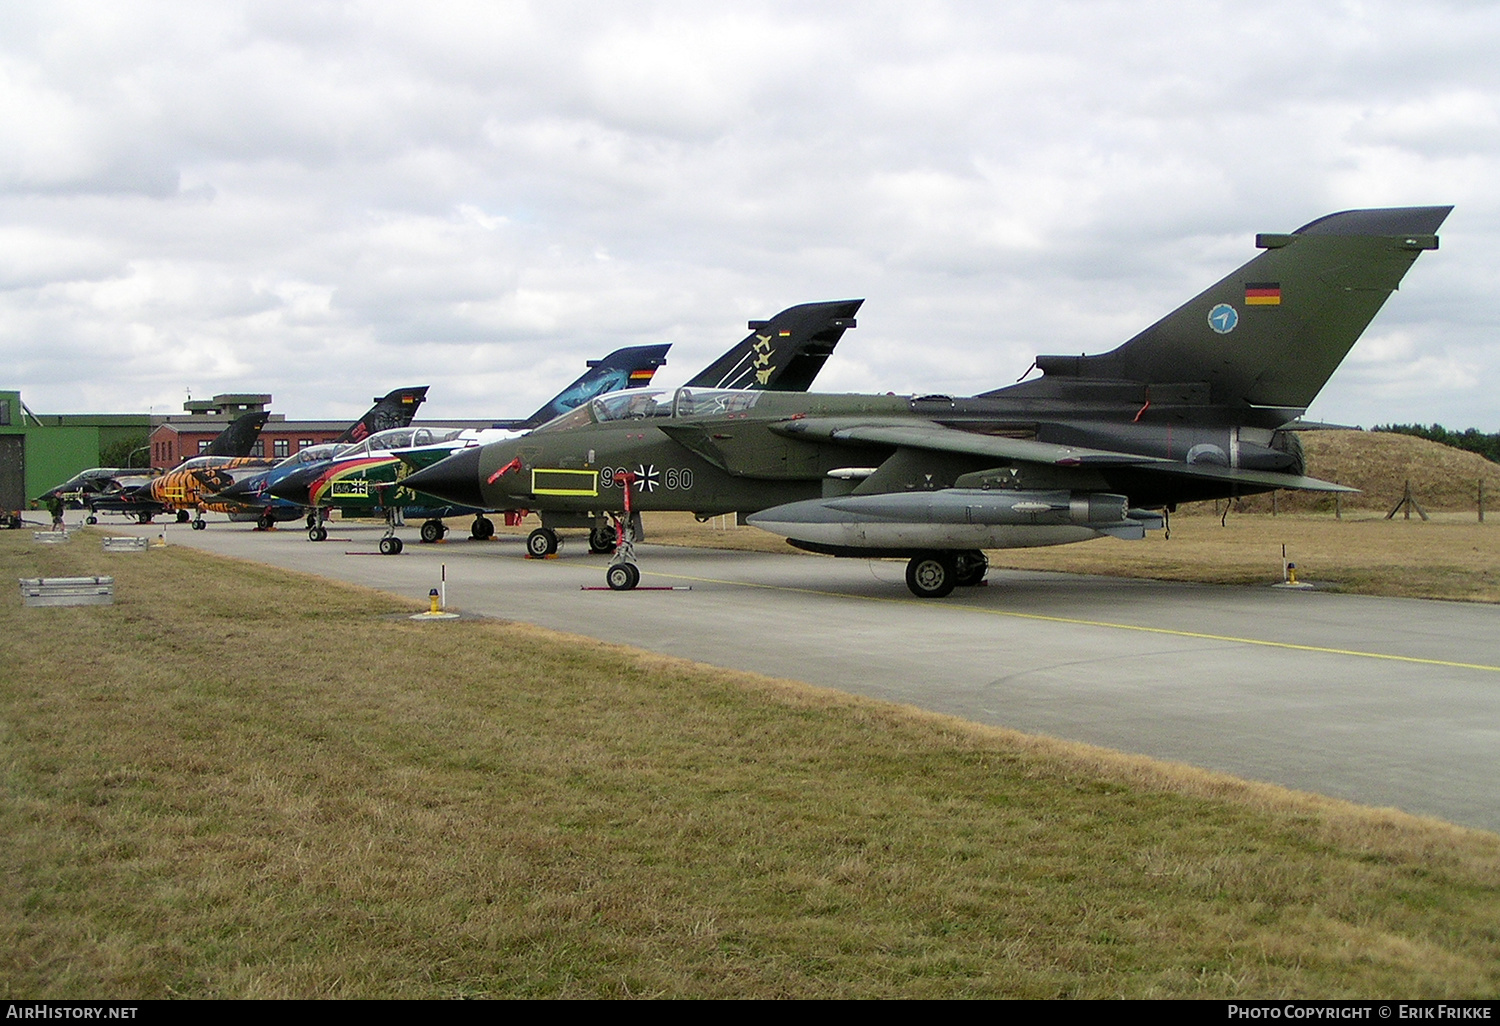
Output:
[{"left": 0, "top": 531, "right": 1500, "bottom": 998}]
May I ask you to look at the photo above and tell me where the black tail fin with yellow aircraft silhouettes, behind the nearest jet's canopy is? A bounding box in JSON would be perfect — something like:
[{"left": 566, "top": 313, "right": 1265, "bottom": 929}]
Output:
[{"left": 687, "top": 300, "right": 864, "bottom": 392}]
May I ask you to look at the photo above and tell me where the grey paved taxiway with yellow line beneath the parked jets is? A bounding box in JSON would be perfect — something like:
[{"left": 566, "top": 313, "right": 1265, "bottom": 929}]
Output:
[{"left": 93, "top": 519, "right": 1500, "bottom": 831}]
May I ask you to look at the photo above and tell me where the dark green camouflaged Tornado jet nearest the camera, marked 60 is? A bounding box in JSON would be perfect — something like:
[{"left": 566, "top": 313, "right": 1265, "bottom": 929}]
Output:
[{"left": 407, "top": 207, "right": 1452, "bottom": 597}]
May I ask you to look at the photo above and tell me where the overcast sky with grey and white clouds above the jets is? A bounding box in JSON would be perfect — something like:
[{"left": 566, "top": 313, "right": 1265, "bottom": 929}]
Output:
[{"left": 0, "top": 0, "right": 1500, "bottom": 431}]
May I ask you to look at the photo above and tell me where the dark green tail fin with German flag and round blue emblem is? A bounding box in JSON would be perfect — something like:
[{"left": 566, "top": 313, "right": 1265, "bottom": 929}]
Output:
[{"left": 1028, "top": 207, "right": 1452, "bottom": 410}]
